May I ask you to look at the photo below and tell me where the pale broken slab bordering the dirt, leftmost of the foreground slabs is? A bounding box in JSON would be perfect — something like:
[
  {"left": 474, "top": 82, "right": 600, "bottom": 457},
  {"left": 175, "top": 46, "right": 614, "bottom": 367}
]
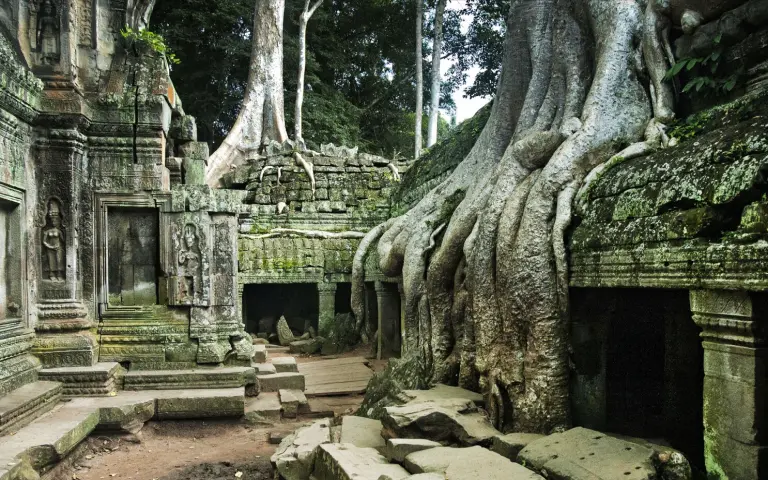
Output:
[{"left": 271, "top": 419, "right": 331, "bottom": 480}]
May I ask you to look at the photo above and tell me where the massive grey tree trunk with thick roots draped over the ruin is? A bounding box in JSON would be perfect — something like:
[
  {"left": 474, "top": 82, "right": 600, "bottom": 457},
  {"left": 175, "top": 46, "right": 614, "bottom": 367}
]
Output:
[{"left": 353, "top": 0, "right": 668, "bottom": 433}]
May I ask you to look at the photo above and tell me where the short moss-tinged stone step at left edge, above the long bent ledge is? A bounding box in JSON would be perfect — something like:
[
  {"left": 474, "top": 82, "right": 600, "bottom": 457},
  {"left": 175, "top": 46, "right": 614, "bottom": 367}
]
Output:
[{"left": 0, "top": 381, "right": 62, "bottom": 436}]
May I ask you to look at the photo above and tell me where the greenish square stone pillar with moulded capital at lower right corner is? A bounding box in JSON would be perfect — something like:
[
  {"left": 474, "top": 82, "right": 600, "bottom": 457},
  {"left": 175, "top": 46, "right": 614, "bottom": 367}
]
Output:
[{"left": 690, "top": 290, "right": 768, "bottom": 479}]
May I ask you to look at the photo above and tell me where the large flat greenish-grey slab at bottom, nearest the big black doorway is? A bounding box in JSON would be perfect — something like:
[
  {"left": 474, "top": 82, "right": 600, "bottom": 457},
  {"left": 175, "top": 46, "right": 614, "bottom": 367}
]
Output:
[{"left": 518, "top": 427, "right": 659, "bottom": 480}]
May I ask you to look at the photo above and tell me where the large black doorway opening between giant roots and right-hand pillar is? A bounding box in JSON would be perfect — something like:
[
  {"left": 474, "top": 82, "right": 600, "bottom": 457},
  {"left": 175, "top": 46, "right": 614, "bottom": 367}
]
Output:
[{"left": 571, "top": 288, "right": 704, "bottom": 467}]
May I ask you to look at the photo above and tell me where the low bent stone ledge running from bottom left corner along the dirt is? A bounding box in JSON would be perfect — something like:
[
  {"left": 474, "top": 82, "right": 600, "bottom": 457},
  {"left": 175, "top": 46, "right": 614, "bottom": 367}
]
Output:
[{"left": 0, "top": 388, "right": 245, "bottom": 480}]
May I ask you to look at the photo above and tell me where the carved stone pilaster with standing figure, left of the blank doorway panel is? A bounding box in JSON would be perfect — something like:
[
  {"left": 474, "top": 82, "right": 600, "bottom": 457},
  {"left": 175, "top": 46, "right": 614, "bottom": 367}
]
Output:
[{"left": 32, "top": 129, "right": 98, "bottom": 368}]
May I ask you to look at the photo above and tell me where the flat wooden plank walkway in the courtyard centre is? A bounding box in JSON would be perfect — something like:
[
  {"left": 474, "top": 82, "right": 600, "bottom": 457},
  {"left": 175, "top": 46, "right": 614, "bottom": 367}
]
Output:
[{"left": 299, "top": 357, "right": 373, "bottom": 397}]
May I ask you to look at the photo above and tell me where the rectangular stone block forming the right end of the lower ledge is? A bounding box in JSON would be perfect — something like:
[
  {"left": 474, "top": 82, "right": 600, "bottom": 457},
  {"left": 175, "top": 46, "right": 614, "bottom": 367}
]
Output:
[{"left": 156, "top": 388, "right": 245, "bottom": 420}]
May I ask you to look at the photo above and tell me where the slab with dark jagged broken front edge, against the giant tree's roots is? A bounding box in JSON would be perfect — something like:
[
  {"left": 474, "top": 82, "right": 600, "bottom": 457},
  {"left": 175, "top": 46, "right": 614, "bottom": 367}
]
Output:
[{"left": 382, "top": 399, "right": 500, "bottom": 446}]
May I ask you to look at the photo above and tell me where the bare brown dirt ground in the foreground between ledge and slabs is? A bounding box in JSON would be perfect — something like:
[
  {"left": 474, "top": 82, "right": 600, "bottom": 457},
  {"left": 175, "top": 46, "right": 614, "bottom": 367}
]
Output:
[{"left": 67, "top": 420, "right": 303, "bottom": 480}]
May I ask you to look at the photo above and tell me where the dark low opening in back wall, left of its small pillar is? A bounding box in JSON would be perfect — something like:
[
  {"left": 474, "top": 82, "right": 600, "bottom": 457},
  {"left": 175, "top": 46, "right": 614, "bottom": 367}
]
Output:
[{"left": 243, "top": 283, "right": 319, "bottom": 337}]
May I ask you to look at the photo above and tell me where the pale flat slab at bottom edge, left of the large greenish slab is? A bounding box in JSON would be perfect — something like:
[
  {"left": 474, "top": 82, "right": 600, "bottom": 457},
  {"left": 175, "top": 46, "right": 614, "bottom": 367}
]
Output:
[{"left": 404, "top": 446, "right": 540, "bottom": 480}]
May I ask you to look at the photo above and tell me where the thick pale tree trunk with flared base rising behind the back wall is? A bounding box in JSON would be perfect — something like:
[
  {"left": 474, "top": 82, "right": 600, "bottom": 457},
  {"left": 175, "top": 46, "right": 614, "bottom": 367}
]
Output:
[{"left": 206, "top": 0, "right": 288, "bottom": 188}]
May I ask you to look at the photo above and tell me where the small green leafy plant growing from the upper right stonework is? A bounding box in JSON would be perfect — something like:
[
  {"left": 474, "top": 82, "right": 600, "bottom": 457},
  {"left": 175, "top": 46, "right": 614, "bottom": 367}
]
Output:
[{"left": 664, "top": 35, "right": 744, "bottom": 95}]
